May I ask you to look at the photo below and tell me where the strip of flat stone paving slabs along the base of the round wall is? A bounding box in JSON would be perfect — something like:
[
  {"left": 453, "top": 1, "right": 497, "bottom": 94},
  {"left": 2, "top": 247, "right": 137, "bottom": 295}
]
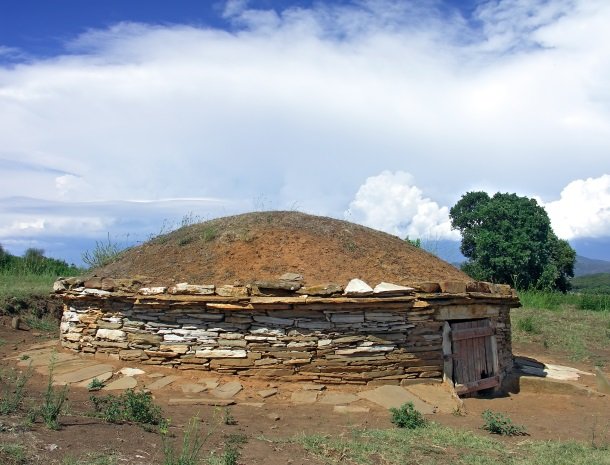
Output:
[{"left": 11, "top": 341, "right": 460, "bottom": 414}]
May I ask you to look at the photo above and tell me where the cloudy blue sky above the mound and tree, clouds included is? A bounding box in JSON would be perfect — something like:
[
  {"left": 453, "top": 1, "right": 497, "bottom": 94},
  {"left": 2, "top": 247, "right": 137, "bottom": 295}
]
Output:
[{"left": 0, "top": 0, "right": 610, "bottom": 261}]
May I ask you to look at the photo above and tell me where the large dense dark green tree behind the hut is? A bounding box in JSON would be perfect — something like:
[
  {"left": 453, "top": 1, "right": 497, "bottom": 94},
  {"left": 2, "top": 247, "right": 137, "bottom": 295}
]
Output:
[{"left": 449, "top": 192, "right": 576, "bottom": 292}]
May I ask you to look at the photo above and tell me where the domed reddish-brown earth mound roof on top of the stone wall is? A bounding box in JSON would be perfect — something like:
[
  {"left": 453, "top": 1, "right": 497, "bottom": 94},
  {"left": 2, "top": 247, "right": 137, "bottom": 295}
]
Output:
[{"left": 94, "top": 211, "right": 471, "bottom": 286}]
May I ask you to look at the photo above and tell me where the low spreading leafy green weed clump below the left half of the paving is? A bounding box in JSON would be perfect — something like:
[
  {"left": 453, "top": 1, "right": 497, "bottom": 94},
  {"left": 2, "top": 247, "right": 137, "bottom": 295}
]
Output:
[{"left": 89, "top": 389, "right": 166, "bottom": 426}]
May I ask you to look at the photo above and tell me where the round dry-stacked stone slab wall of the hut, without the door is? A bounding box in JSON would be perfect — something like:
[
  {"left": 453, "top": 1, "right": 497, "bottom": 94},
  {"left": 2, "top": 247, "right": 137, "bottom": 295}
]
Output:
[{"left": 54, "top": 276, "right": 519, "bottom": 384}]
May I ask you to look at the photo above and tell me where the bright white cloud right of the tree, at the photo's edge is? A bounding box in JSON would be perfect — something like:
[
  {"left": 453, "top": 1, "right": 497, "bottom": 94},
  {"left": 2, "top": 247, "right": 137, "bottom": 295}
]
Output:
[{"left": 544, "top": 174, "right": 610, "bottom": 239}]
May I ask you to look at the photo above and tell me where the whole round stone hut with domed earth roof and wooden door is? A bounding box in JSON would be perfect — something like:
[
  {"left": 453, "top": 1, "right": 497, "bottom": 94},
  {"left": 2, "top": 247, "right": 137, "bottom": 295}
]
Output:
[{"left": 54, "top": 212, "right": 519, "bottom": 394}]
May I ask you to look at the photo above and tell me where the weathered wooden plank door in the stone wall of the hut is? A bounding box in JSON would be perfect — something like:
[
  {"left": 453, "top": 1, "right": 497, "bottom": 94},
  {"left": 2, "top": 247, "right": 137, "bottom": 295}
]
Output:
[{"left": 450, "top": 319, "right": 500, "bottom": 395}]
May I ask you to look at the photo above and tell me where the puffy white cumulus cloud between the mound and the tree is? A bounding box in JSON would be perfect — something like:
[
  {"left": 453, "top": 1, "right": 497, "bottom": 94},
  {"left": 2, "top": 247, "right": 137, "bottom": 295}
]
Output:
[{"left": 345, "top": 171, "right": 460, "bottom": 240}]
